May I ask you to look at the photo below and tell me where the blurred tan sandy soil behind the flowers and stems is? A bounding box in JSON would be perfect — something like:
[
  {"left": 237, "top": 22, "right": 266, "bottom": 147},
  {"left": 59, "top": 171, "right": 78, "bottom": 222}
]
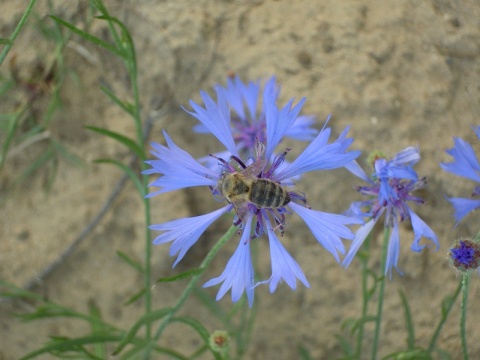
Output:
[{"left": 0, "top": 0, "right": 480, "bottom": 360}]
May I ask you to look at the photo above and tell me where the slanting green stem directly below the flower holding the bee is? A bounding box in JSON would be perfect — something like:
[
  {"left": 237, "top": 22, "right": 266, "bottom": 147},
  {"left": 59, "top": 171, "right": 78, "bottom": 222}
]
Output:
[{"left": 144, "top": 225, "right": 237, "bottom": 359}]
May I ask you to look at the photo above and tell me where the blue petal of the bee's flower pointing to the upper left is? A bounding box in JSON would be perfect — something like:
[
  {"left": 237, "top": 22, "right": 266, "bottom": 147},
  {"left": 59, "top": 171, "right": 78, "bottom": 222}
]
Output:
[{"left": 184, "top": 90, "right": 238, "bottom": 156}]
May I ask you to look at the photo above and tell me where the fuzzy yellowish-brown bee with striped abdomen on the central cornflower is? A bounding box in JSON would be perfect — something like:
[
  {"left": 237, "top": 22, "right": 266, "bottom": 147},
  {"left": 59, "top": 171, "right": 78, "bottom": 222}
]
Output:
[{"left": 217, "top": 159, "right": 290, "bottom": 222}]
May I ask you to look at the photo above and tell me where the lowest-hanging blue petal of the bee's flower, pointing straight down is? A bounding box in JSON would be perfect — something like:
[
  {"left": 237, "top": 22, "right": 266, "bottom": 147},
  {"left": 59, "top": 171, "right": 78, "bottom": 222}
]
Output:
[{"left": 203, "top": 216, "right": 254, "bottom": 307}]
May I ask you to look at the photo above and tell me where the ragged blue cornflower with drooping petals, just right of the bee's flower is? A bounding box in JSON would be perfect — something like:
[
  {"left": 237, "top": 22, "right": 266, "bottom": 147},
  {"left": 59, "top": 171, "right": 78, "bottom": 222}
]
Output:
[{"left": 342, "top": 147, "right": 439, "bottom": 275}]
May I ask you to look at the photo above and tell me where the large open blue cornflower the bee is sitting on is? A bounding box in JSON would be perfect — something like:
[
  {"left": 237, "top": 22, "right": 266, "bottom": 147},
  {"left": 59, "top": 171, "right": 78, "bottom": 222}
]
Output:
[{"left": 145, "top": 119, "right": 360, "bottom": 305}]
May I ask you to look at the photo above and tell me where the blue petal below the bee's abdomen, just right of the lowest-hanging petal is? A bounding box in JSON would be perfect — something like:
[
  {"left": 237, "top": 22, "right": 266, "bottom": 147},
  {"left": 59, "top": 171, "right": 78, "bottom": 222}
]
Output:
[{"left": 267, "top": 222, "right": 310, "bottom": 293}]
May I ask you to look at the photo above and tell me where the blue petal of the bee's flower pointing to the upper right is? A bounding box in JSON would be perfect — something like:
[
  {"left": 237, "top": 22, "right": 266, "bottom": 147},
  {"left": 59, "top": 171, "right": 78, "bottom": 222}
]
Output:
[{"left": 277, "top": 127, "right": 360, "bottom": 181}]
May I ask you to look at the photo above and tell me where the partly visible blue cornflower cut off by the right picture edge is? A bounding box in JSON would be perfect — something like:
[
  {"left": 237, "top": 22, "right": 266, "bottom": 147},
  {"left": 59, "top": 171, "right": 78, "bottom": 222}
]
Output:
[{"left": 440, "top": 126, "right": 480, "bottom": 224}]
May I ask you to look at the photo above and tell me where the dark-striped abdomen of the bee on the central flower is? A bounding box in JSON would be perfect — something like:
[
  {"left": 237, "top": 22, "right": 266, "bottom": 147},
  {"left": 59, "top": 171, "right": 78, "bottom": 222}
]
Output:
[{"left": 250, "top": 179, "right": 290, "bottom": 208}]
